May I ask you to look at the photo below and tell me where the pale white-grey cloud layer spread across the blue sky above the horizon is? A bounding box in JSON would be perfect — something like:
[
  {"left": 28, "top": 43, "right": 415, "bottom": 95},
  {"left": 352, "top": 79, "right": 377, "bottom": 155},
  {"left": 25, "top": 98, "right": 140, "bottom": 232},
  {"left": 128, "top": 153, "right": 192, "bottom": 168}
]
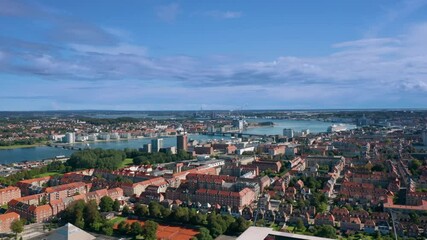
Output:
[{"left": 0, "top": 1, "right": 427, "bottom": 110}]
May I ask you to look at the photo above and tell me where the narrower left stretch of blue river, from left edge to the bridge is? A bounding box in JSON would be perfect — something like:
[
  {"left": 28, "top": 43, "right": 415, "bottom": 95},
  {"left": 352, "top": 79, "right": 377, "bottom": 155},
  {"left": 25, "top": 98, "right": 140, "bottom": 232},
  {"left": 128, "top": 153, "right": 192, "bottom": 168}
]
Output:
[{"left": 0, "top": 134, "right": 229, "bottom": 164}]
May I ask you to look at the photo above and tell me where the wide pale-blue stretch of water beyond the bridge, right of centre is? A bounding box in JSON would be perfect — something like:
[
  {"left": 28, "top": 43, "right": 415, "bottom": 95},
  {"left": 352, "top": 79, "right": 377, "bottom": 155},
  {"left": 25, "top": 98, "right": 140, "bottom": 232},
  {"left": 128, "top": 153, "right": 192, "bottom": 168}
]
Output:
[{"left": 244, "top": 119, "right": 356, "bottom": 135}]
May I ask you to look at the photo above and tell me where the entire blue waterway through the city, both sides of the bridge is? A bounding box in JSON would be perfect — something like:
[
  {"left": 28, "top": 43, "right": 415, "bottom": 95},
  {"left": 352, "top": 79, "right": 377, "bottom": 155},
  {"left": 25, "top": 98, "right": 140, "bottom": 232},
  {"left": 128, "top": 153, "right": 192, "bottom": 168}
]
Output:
[{"left": 0, "top": 119, "right": 356, "bottom": 164}]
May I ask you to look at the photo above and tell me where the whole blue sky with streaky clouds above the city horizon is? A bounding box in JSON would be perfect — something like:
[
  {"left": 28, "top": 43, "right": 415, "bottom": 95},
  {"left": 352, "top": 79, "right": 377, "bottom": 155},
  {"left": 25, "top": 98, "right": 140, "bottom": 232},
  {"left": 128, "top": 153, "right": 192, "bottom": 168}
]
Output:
[{"left": 0, "top": 0, "right": 427, "bottom": 111}]
